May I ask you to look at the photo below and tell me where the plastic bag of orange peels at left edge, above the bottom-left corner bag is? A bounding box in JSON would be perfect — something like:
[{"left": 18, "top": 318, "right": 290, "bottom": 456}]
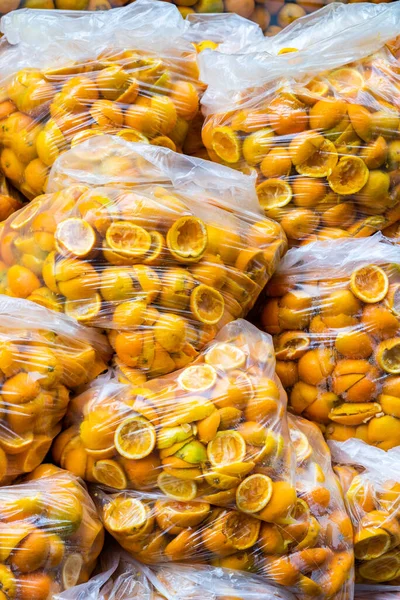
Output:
[{"left": 0, "top": 292, "right": 109, "bottom": 486}]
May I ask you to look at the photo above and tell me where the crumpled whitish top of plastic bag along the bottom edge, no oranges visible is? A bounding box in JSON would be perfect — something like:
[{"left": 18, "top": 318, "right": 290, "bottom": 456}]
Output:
[{"left": 55, "top": 548, "right": 294, "bottom": 600}]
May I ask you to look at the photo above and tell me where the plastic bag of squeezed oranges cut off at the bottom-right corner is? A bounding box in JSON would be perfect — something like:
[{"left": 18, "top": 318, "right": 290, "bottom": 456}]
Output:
[{"left": 330, "top": 439, "right": 400, "bottom": 588}]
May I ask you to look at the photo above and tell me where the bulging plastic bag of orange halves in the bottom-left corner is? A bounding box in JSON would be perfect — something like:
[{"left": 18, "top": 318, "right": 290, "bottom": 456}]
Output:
[{"left": 0, "top": 465, "right": 104, "bottom": 600}]
